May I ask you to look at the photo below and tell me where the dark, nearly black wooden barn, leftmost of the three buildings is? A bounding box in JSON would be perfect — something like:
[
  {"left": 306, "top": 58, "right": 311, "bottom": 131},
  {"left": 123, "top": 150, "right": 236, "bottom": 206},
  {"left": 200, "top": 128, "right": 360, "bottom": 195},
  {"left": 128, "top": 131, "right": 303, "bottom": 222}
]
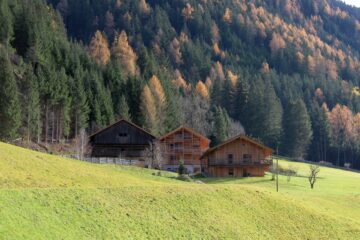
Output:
[{"left": 90, "top": 119, "right": 155, "bottom": 165}]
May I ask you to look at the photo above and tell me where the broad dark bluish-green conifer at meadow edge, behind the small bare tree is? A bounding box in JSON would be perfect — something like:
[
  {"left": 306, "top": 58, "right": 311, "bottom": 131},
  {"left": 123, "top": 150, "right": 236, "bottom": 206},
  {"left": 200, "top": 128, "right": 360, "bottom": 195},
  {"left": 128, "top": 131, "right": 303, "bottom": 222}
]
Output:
[{"left": 282, "top": 99, "right": 312, "bottom": 158}]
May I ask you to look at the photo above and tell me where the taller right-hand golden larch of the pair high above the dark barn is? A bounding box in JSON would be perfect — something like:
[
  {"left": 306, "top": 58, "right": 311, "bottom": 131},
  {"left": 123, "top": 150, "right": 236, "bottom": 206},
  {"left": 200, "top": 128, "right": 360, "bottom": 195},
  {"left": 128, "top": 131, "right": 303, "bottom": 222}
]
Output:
[{"left": 111, "top": 31, "right": 138, "bottom": 75}]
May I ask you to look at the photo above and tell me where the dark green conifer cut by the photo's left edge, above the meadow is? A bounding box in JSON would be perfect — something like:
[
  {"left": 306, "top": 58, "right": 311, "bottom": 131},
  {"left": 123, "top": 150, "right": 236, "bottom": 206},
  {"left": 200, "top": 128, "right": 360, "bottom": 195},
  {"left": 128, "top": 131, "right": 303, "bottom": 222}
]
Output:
[{"left": 0, "top": 46, "right": 21, "bottom": 140}]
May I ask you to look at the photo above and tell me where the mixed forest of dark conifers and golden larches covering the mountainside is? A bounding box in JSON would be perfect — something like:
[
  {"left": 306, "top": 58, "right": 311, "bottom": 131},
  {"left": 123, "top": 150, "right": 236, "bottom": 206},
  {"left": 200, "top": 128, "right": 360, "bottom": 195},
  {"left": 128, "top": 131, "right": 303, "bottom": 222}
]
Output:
[{"left": 0, "top": 0, "right": 360, "bottom": 169}]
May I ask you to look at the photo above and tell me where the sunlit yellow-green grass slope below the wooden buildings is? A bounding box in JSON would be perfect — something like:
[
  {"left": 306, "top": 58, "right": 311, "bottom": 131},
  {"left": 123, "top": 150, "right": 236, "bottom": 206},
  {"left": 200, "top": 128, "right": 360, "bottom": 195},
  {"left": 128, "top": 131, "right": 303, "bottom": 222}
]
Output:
[{"left": 0, "top": 143, "right": 360, "bottom": 239}]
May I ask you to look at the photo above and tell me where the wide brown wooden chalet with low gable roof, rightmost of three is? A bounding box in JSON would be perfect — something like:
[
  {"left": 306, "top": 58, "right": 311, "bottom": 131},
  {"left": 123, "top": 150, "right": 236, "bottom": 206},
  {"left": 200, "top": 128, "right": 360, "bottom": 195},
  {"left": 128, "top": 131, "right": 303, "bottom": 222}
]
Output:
[{"left": 202, "top": 135, "right": 273, "bottom": 177}]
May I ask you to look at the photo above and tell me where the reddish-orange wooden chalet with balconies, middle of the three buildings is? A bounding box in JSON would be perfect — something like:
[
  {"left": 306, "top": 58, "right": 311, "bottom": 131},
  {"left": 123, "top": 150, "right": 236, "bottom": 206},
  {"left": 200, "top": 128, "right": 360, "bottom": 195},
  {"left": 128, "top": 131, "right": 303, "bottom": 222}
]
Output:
[{"left": 159, "top": 127, "right": 210, "bottom": 173}]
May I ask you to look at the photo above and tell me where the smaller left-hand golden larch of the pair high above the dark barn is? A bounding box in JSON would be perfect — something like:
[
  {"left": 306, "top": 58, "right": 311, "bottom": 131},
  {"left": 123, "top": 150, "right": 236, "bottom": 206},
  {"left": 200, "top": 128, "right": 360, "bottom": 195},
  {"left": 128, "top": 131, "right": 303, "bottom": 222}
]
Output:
[{"left": 89, "top": 31, "right": 110, "bottom": 65}]
